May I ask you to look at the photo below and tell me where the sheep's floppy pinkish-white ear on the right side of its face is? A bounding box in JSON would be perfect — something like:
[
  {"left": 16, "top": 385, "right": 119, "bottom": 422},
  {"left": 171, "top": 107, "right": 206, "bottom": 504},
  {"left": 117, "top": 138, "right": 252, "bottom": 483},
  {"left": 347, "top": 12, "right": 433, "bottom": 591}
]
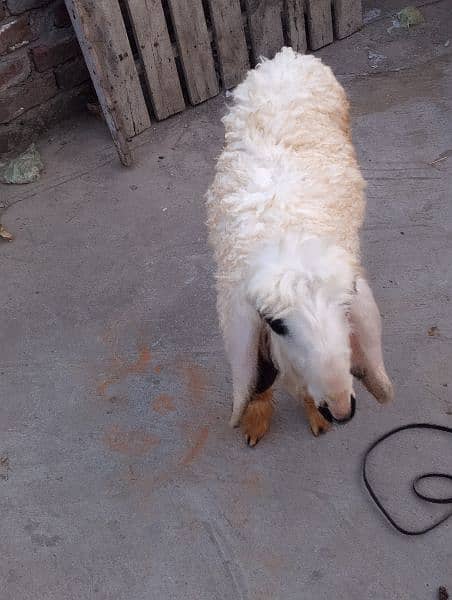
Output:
[{"left": 350, "top": 277, "right": 393, "bottom": 402}]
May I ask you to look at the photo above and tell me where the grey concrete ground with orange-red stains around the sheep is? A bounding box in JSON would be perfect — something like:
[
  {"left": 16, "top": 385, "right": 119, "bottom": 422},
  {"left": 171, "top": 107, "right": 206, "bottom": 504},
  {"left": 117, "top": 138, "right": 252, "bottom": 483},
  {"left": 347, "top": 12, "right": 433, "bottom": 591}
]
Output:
[{"left": 0, "top": 0, "right": 452, "bottom": 600}]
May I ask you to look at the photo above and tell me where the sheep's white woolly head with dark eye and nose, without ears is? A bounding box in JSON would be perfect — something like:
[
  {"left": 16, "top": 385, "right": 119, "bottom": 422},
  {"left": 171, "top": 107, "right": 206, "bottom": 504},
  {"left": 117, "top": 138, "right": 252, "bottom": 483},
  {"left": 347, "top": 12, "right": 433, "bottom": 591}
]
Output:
[{"left": 248, "top": 238, "right": 355, "bottom": 421}]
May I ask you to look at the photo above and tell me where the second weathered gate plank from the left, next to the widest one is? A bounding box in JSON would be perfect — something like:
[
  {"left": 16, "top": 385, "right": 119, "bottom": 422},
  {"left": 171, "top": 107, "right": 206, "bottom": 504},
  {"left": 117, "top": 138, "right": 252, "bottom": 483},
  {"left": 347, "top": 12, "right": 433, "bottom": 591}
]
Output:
[{"left": 125, "top": 0, "right": 185, "bottom": 120}]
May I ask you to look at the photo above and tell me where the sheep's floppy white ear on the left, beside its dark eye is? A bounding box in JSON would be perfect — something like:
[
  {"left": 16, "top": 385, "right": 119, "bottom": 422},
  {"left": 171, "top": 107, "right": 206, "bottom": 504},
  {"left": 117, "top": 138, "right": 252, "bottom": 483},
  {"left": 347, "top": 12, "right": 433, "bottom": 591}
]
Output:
[{"left": 222, "top": 302, "right": 261, "bottom": 427}]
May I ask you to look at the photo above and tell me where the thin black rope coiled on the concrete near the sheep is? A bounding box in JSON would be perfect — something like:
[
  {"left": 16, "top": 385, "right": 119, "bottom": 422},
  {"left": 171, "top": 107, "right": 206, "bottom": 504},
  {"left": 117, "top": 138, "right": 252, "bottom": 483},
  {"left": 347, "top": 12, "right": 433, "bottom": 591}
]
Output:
[{"left": 362, "top": 423, "right": 452, "bottom": 535}]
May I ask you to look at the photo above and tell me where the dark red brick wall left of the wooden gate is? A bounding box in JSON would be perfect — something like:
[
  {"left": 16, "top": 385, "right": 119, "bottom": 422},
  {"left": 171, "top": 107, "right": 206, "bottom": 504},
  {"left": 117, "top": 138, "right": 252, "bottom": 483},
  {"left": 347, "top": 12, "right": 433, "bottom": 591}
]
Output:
[{"left": 0, "top": 0, "right": 91, "bottom": 154}]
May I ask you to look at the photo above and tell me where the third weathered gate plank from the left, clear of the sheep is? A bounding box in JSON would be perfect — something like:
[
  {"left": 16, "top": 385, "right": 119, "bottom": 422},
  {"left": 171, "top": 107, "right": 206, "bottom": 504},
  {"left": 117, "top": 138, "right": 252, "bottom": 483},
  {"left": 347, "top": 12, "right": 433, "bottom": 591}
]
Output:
[{"left": 168, "top": 0, "right": 219, "bottom": 104}]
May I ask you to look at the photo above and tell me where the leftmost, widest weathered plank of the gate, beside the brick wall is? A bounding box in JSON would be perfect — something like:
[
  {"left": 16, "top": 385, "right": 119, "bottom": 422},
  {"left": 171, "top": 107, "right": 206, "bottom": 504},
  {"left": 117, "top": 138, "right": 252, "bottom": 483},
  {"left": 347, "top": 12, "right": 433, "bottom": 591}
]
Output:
[{"left": 65, "top": 0, "right": 151, "bottom": 165}]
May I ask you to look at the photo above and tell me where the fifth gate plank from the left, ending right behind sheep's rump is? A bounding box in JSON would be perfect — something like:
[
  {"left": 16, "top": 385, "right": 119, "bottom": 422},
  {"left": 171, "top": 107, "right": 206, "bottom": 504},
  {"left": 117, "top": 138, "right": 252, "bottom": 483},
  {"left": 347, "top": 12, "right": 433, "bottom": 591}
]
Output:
[{"left": 245, "top": 0, "right": 284, "bottom": 63}]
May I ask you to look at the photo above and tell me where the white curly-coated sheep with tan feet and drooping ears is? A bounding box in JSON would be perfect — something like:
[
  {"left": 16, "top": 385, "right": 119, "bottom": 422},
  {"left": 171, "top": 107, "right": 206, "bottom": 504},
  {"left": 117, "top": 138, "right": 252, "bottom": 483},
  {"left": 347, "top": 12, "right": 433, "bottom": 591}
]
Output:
[{"left": 207, "top": 48, "right": 392, "bottom": 445}]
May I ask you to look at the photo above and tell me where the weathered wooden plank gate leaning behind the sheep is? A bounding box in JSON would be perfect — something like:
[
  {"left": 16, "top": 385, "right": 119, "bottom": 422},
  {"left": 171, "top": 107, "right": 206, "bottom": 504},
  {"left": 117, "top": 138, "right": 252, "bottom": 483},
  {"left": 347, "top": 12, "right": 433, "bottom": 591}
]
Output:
[{"left": 65, "top": 0, "right": 362, "bottom": 165}]
